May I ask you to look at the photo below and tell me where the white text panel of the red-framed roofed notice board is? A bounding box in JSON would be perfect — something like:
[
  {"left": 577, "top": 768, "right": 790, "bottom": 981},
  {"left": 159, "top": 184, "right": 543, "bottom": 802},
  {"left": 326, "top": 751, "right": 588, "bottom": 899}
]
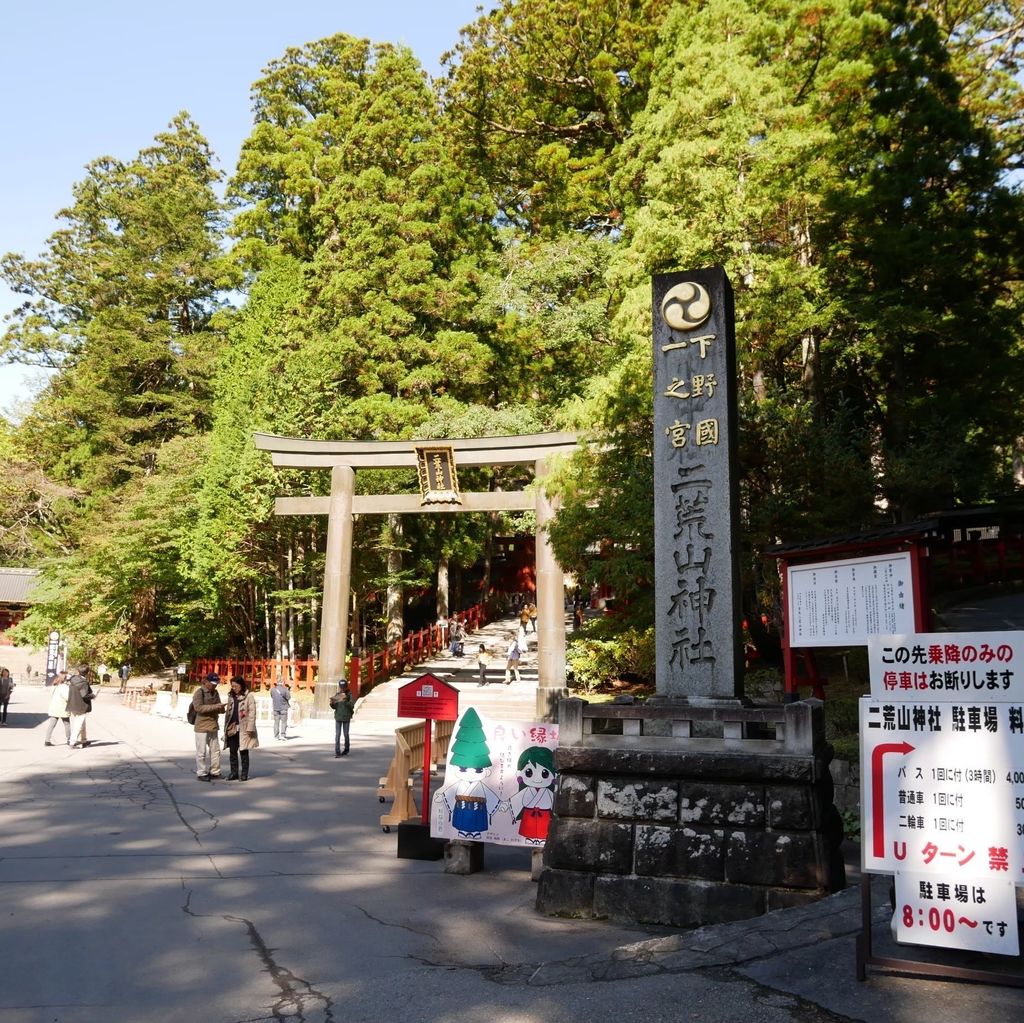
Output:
[{"left": 786, "top": 553, "right": 914, "bottom": 647}]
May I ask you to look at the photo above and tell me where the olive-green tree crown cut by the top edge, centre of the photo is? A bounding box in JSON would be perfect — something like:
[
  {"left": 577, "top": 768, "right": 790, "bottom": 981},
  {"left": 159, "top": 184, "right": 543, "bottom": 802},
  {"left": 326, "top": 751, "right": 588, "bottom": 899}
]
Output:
[{"left": 439, "top": 0, "right": 671, "bottom": 237}]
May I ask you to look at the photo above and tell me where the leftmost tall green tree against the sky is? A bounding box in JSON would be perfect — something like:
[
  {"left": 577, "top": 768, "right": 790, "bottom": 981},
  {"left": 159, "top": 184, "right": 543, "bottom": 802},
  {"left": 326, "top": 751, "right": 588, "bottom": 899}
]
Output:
[{"left": 0, "top": 114, "right": 233, "bottom": 492}]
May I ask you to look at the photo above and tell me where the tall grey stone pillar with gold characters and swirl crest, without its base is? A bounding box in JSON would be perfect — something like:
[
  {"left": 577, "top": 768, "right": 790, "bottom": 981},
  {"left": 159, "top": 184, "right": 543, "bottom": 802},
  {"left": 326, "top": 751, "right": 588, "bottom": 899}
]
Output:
[{"left": 652, "top": 266, "right": 743, "bottom": 699}]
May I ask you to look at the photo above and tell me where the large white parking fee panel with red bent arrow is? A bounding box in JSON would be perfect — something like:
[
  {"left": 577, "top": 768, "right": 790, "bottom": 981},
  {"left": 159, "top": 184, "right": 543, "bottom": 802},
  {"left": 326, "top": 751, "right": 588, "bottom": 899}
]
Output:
[{"left": 860, "top": 693, "right": 1024, "bottom": 885}]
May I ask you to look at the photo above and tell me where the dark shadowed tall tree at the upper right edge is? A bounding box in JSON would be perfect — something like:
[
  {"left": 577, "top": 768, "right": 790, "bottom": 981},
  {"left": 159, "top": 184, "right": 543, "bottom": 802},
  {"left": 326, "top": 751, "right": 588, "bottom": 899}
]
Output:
[{"left": 821, "top": 2, "right": 1024, "bottom": 520}]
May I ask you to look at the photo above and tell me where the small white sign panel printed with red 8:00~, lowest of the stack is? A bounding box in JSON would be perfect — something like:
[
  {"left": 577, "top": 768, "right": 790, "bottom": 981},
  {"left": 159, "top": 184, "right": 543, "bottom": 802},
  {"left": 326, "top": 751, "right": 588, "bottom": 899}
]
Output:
[{"left": 896, "top": 870, "right": 1020, "bottom": 955}]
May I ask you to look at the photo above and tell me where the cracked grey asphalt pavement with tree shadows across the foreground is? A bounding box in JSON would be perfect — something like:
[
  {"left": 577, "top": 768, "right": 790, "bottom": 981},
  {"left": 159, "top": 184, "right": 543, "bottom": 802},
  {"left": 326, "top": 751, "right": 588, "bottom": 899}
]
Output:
[{"left": 0, "top": 686, "right": 1024, "bottom": 1023}]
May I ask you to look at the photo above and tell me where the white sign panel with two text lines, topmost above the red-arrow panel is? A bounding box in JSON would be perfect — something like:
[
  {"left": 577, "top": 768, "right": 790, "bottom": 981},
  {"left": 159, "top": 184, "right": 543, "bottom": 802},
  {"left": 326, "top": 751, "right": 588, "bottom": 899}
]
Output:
[{"left": 867, "top": 632, "right": 1024, "bottom": 704}]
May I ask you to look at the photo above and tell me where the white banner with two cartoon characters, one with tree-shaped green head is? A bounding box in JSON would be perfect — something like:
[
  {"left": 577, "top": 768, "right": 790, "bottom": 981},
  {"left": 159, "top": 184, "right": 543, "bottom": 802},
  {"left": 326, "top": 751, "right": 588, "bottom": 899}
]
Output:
[{"left": 430, "top": 707, "right": 558, "bottom": 849}]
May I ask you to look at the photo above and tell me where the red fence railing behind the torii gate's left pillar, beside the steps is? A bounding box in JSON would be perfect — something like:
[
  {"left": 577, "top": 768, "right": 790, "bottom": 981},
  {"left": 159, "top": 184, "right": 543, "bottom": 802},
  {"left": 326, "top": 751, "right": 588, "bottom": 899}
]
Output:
[{"left": 188, "top": 604, "right": 487, "bottom": 698}]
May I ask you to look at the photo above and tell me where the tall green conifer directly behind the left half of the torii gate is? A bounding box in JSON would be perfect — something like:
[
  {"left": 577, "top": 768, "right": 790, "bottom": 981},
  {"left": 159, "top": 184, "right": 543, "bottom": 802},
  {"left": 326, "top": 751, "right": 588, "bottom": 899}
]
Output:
[{"left": 207, "top": 36, "right": 507, "bottom": 651}]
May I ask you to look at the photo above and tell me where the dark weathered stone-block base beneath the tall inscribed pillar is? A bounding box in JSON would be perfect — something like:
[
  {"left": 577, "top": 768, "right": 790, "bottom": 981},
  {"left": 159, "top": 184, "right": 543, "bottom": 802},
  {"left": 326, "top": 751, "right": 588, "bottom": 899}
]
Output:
[{"left": 537, "top": 699, "right": 846, "bottom": 927}]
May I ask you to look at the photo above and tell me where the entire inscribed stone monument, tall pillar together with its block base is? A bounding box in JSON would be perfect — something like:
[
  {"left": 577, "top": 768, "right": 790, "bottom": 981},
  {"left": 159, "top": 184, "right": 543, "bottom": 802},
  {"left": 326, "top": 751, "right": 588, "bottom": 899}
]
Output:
[{"left": 537, "top": 267, "right": 845, "bottom": 927}]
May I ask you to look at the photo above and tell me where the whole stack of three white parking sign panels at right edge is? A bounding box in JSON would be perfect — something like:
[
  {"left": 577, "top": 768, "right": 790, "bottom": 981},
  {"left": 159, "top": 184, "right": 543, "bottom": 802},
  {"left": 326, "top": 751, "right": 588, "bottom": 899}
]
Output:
[{"left": 860, "top": 633, "right": 1024, "bottom": 955}]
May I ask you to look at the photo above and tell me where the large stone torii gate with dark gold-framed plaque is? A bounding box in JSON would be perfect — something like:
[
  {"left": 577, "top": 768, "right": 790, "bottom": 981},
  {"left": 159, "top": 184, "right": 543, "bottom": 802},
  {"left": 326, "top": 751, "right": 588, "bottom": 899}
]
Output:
[{"left": 253, "top": 433, "right": 578, "bottom": 717}]
